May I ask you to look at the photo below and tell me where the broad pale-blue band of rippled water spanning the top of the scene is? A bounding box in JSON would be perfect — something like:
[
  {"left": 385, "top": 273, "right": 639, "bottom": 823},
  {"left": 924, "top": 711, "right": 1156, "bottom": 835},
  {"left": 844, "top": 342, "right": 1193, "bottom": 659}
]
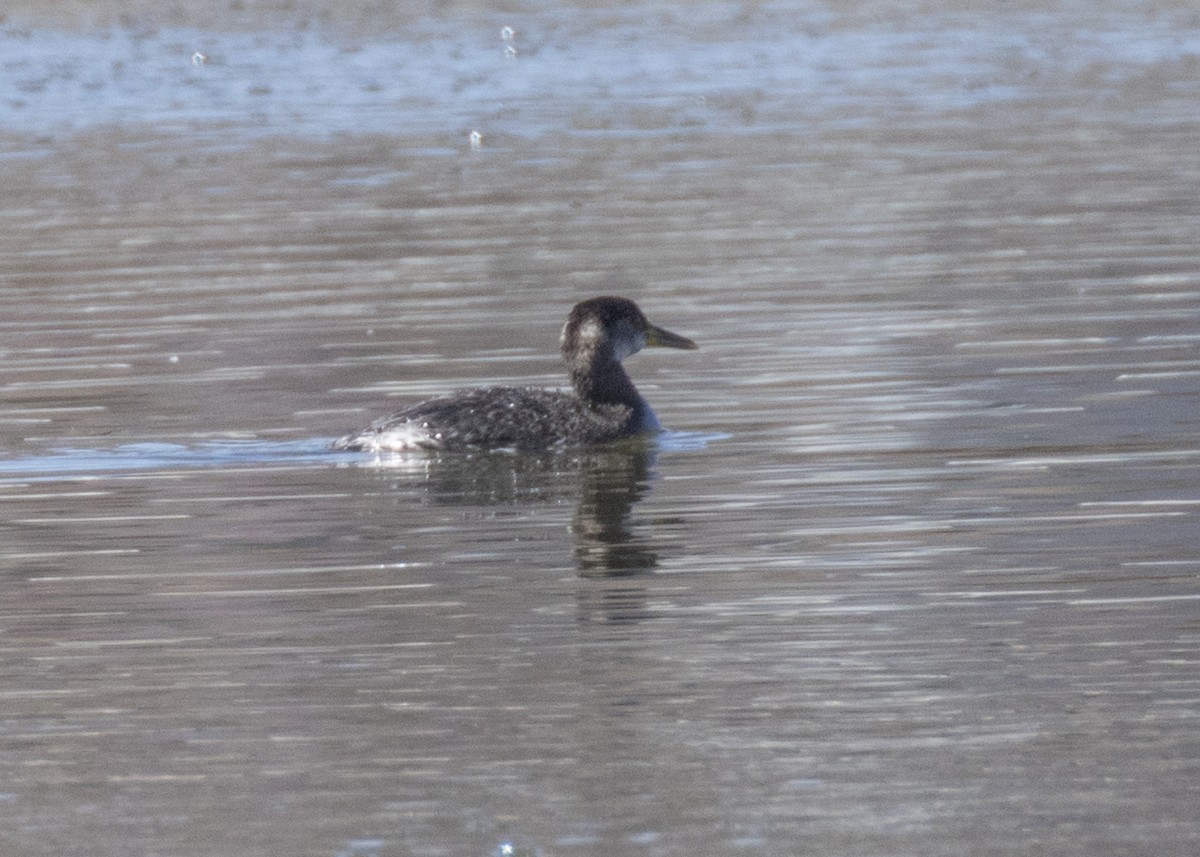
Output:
[{"left": 0, "top": 10, "right": 1200, "bottom": 140}]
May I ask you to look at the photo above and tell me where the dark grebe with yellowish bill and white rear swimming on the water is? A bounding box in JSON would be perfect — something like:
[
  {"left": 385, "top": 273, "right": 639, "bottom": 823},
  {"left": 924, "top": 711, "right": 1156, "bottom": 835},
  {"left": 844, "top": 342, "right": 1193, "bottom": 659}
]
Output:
[{"left": 334, "top": 298, "right": 698, "bottom": 453}]
